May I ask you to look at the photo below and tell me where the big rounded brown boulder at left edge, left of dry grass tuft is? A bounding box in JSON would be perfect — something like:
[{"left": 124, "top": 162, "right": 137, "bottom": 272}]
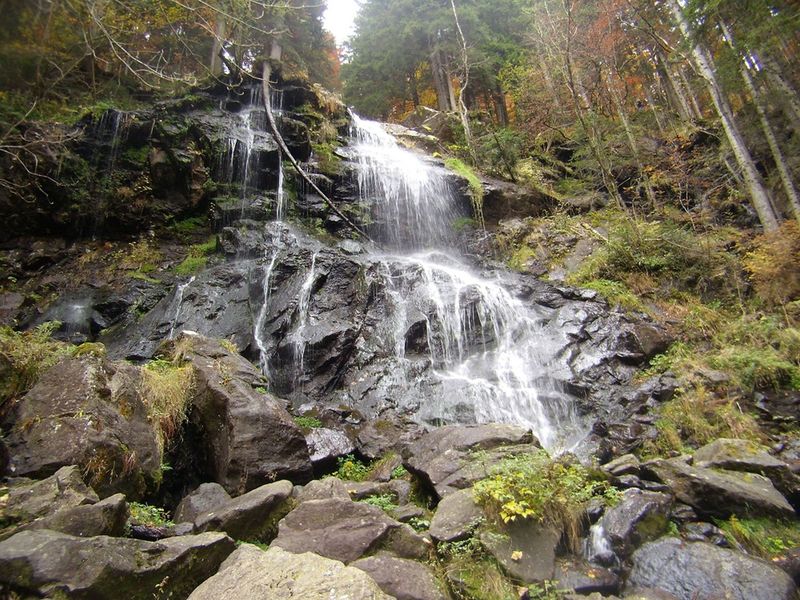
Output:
[{"left": 4, "top": 356, "right": 161, "bottom": 498}]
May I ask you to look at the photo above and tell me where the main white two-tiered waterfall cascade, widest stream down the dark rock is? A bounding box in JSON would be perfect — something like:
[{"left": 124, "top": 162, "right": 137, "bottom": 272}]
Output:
[{"left": 351, "top": 117, "right": 585, "bottom": 450}]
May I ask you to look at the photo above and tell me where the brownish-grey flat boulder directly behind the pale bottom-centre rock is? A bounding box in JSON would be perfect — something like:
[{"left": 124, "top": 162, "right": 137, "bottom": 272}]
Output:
[{"left": 273, "top": 498, "right": 416, "bottom": 563}]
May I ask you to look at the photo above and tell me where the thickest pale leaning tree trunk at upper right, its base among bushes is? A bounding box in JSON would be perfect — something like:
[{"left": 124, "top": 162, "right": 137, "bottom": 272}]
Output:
[{"left": 667, "top": 0, "right": 778, "bottom": 231}]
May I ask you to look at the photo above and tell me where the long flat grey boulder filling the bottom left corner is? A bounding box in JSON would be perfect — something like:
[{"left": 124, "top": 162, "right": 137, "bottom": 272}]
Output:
[{"left": 0, "top": 530, "right": 235, "bottom": 600}]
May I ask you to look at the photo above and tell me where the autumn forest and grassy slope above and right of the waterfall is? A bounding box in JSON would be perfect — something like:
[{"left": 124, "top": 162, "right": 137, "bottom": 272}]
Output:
[{"left": 0, "top": 0, "right": 800, "bottom": 464}]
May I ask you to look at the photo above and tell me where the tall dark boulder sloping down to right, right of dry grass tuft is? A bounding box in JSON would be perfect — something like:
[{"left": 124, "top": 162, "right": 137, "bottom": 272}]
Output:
[{"left": 175, "top": 332, "right": 313, "bottom": 494}]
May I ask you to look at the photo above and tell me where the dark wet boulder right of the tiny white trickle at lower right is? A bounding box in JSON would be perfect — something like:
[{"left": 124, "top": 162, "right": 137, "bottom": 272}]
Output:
[{"left": 600, "top": 489, "right": 672, "bottom": 558}]
